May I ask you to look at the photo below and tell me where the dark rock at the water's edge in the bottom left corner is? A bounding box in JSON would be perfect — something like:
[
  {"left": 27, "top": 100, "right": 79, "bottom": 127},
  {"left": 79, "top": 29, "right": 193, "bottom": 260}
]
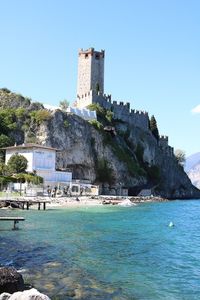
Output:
[{"left": 0, "top": 267, "right": 24, "bottom": 293}]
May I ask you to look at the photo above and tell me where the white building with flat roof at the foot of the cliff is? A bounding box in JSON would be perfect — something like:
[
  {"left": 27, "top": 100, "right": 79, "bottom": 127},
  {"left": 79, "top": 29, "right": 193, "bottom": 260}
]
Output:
[{"left": 5, "top": 144, "right": 72, "bottom": 186}]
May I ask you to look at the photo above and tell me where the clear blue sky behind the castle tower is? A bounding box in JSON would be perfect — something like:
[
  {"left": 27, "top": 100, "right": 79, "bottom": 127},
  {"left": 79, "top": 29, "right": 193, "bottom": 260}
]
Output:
[{"left": 0, "top": 0, "right": 200, "bottom": 155}]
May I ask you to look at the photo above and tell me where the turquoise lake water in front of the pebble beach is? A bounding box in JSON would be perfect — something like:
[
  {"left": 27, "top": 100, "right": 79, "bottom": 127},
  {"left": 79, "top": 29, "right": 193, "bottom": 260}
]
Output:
[{"left": 0, "top": 200, "right": 200, "bottom": 300}]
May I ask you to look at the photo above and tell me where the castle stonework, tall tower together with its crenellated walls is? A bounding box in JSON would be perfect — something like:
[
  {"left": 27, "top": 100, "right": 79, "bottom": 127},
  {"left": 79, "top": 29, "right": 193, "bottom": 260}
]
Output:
[{"left": 76, "top": 48, "right": 173, "bottom": 155}]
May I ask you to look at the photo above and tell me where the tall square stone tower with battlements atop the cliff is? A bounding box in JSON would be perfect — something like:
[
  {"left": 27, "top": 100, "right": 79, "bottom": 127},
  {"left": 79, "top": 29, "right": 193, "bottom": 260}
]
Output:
[{"left": 77, "top": 48, "right": 105, "bottom": 108}]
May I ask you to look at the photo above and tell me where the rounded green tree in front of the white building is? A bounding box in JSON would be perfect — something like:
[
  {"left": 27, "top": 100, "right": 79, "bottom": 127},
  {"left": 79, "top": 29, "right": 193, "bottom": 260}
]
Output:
[{"left": 7, "top": 154, "right": 28, "bottom": 174}]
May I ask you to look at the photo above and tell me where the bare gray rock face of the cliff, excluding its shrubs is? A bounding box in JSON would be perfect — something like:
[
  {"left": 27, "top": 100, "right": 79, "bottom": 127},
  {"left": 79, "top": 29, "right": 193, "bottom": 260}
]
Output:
[{"left": 29, "top": 110, "right": 200, "bottom": 199}]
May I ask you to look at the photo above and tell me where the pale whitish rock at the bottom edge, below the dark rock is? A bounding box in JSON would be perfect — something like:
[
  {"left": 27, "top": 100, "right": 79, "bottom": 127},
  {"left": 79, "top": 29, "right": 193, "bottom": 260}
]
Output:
[{"left": 0, "top": 289, "right": 51, "bottom": 300}]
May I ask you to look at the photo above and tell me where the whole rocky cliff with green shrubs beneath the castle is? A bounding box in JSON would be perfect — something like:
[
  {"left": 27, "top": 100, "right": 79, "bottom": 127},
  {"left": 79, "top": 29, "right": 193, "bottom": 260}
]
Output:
[{"left": 0, "top": 90, "right": 200, "bottom": 198}]
